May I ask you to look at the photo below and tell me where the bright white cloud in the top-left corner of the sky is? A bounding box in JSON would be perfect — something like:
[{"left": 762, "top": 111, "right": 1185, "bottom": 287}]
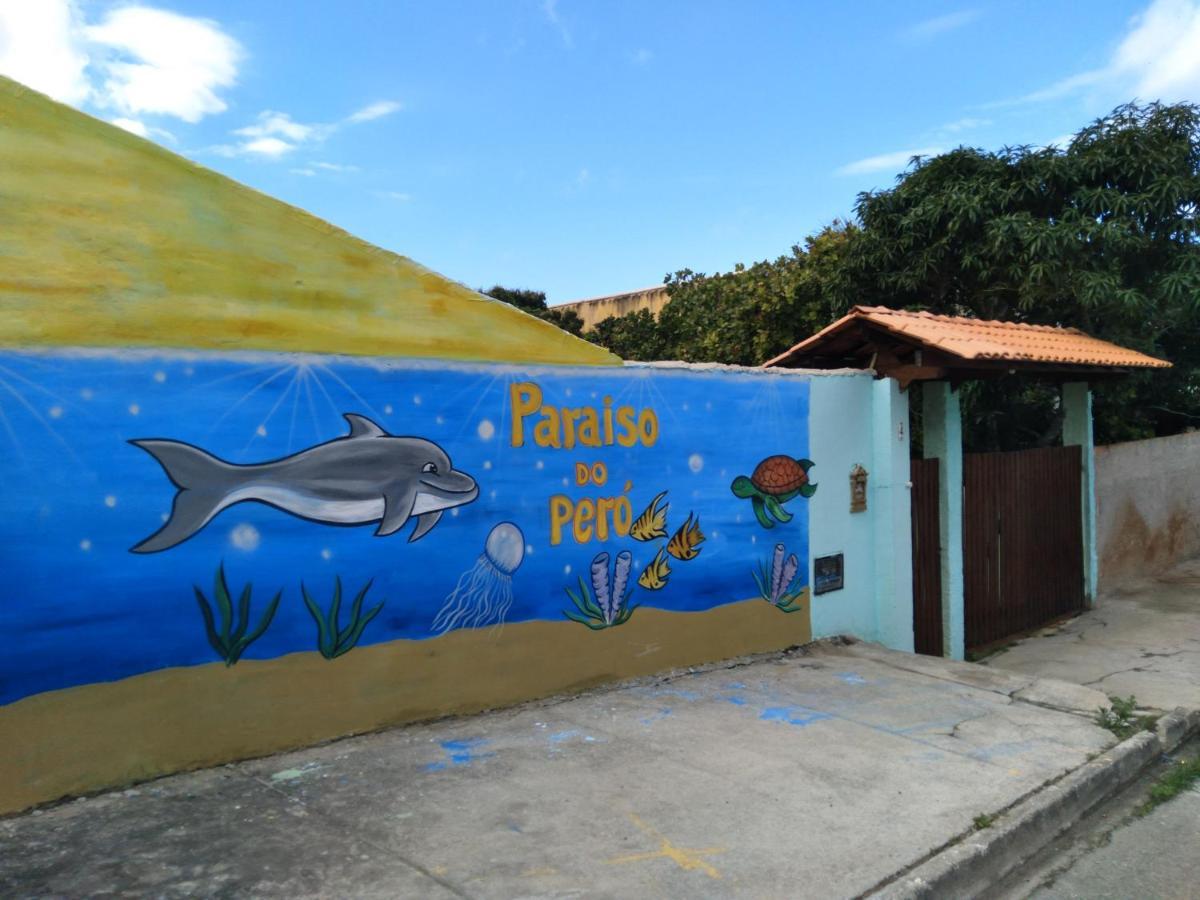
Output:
[{"left": 0, "top": 0, "right": 91, "bottom": 104}]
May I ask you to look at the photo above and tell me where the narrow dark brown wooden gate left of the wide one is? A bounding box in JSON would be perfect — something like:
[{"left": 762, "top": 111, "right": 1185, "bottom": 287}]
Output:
[{"left": 910, "top": 460, "right": 942, "bottom": 656}]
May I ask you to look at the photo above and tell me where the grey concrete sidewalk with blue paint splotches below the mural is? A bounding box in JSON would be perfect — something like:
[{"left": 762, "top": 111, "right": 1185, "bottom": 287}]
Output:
[{"left": 0, "top": 642, "right": 1114, "bottom": 898}]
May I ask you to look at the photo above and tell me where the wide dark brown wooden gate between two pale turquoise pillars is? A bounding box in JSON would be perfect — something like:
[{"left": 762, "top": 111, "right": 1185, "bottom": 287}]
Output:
[{"left": 964, "top": 446, "right": 1084, "bottom": 649}]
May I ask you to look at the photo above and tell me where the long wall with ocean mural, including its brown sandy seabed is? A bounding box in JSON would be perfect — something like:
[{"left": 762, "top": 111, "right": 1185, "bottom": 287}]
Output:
[{"left": 0, "top": 350, "right": 871, "bottom": 809}]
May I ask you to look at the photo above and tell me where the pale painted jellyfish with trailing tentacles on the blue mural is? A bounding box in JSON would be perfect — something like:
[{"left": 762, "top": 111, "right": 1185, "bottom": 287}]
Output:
[{"left": 433, "top": 522, "right": 524, "bottom": 634}]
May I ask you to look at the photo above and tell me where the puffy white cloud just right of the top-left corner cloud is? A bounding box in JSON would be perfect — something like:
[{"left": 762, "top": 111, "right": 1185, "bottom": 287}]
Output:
[{"left": 85, "top": 6, "right": 242, "bottom": 122}]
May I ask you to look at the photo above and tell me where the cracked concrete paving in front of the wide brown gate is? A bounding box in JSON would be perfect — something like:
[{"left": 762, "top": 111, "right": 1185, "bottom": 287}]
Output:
[{"left": 985, "top": 560, "right": 1200, "bottom": 709}]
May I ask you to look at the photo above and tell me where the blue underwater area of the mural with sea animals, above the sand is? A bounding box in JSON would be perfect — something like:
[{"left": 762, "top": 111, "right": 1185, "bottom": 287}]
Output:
[{"left": 0, "top": 352, "right": 822, "bottom": 703}]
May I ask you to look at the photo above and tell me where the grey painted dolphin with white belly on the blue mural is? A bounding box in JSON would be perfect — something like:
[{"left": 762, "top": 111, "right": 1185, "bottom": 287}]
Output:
[{"left": 130, "top": 413, "right": 479, "bottom": 553}]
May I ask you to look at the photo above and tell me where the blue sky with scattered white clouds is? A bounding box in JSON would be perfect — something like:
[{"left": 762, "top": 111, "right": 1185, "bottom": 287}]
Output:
[{"left": 0, "top": 0, "right": 1200, "bottom": 302}]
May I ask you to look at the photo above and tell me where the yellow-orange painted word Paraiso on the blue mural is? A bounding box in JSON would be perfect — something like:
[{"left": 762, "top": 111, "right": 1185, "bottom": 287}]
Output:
[{"left": 509, "top": 382, "right": 659, "bottom": 450}]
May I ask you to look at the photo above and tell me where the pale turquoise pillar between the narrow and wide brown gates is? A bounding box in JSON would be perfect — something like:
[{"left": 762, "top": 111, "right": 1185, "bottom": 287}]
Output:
[{"left": 922, "top": 382, "right": 966, "bottom": 659}]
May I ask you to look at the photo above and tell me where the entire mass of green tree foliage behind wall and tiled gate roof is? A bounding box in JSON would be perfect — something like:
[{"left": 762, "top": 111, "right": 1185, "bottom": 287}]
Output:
[{"left": 580, "top": 103, "right": 1200, "bottom": 449}]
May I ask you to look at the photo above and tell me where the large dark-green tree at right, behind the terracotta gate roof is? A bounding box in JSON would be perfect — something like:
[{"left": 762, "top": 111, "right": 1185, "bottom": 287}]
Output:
[{"left": 842, "top": 103, "right": 1200, "bottom": 449}]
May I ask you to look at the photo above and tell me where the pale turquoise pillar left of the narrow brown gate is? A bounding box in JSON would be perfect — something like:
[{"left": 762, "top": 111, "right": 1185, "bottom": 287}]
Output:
[{"left": 868, "top": 378, "right": 913, "bottom": 653}]
